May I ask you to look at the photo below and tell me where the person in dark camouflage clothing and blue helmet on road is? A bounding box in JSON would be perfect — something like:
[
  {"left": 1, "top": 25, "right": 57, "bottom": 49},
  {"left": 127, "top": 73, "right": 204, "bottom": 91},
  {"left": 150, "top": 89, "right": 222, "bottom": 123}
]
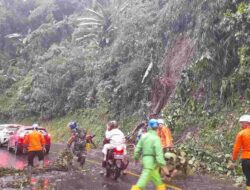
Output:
[{"left": 67, "top": 121, "right": 86, "bottom": 165}]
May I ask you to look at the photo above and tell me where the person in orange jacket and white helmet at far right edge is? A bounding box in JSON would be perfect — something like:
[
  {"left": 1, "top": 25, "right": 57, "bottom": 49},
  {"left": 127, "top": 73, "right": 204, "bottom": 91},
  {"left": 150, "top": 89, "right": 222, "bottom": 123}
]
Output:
[{"left": 232, "top": 115, "right": 250, "bottom": 190}]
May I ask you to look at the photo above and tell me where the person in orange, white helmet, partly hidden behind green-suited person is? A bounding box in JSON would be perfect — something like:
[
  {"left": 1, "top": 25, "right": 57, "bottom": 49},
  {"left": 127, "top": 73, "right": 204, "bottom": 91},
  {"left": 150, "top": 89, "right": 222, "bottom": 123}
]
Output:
[{"left": 157, "top": 119, "right": 174, "bottom": 152}]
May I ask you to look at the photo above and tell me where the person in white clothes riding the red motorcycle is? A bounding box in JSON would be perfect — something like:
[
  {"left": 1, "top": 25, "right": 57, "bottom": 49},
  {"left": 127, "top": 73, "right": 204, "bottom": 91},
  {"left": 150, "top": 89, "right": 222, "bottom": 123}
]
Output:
[{"left": 102, "top": 120, "right": 126, "bottom": 167}]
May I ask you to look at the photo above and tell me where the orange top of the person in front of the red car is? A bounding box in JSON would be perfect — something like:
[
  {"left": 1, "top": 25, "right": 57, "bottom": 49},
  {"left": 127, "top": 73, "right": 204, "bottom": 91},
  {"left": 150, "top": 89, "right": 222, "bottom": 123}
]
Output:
[{"left": 23, "top": 131, "right": 45, "bottom": 152}]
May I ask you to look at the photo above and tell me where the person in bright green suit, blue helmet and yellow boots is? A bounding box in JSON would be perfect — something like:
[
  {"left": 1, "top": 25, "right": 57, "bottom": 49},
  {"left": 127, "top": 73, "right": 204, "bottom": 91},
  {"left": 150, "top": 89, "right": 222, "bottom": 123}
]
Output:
[{"left": 131, "top": 119, "right": 169, "bottom": 190}]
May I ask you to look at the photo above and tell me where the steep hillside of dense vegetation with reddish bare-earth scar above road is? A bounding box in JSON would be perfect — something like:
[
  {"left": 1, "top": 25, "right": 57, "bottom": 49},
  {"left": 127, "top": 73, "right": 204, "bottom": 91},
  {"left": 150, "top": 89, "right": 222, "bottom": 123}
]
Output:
[{"left": 0, "top": 0, "right": 250, "bottom": 182}]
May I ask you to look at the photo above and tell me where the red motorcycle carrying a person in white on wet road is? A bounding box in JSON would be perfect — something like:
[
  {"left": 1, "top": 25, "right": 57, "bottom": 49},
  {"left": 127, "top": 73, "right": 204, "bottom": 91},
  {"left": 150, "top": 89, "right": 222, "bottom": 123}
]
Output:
[{"left": 105, "top": 146, "right": 129, "bottom": 180}]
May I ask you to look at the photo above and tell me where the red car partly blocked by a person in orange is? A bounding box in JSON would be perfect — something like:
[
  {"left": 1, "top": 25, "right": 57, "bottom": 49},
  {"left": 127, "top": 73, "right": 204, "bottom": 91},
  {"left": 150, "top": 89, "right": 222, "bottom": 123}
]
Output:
[{"left": 7, "top": 126, "right": 51, "bottom": 154}]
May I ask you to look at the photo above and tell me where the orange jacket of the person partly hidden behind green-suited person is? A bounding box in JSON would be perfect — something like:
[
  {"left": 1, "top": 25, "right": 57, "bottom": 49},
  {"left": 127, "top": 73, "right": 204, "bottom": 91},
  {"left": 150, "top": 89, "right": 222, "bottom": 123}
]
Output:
[{"left": 157, "top": 125, "right": 174, "bottom": 148}]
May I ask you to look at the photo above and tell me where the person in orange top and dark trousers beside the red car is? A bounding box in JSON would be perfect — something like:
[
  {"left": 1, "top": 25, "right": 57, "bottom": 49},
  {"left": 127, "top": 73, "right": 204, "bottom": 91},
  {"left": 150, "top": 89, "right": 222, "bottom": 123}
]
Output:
[{"left": 23, "top": 124, "right": 46, "bottom": 173}]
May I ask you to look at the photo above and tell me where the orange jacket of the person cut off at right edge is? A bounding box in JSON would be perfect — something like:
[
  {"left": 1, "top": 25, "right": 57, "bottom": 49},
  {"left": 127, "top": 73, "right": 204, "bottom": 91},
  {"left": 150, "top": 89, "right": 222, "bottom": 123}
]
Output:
[{"left": 232, "top": 126, "right": 250, "bottom": 160}]
